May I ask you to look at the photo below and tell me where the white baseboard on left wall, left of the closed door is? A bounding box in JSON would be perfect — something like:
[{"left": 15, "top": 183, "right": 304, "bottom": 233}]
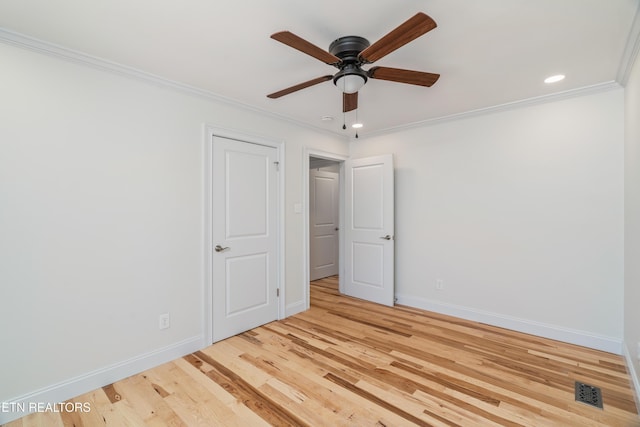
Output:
[{"left": 0, "top": 336, "right": 203, "bottom": 424}]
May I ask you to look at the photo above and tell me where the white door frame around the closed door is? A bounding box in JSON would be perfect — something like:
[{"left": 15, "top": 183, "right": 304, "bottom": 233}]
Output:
[{"left": 202, "top": 124, "right": 286, "bottom": 347}]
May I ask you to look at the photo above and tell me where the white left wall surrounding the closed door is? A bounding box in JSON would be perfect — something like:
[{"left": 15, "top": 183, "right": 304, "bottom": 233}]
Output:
[{"left": 0, "top": 44, "right": 348, "bottom": 423}]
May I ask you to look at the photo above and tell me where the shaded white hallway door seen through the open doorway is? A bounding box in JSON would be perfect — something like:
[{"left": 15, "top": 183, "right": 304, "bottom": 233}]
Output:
[{"left": 309, "top": 170, "right": 340, "bottom": 280}]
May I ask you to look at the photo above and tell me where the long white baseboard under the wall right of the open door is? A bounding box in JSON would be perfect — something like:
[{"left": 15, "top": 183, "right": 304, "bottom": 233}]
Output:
[{"left": 396, "top": 294, "right": 622, "bottom": 355}]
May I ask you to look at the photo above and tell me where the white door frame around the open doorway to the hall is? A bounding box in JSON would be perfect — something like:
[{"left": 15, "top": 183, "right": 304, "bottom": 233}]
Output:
[{"left": 302, "top": 147, "right": 349, "bottom": 310}]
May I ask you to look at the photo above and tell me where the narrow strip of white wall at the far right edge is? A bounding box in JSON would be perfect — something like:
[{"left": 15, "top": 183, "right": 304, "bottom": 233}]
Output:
[{"left": 624, "top": 39, "right": 640, "bottom": 398}]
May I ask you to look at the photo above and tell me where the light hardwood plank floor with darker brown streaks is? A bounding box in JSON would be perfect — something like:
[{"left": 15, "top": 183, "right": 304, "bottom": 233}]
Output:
[{"left": 8, "top": 278, "right": 640, "bottom": 427}]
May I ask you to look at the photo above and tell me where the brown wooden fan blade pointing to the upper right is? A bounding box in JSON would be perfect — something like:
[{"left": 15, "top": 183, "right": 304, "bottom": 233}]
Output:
[{"left": 359, "top": 12, "right": 437, "bottom": 63}]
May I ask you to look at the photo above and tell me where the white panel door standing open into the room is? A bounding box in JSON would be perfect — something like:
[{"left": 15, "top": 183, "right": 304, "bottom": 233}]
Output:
[{"left": 344, "top": 154, "right": 395, "bottom": 306}]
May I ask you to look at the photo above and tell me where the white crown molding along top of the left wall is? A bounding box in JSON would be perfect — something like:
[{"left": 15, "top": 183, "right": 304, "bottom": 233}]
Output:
[{"left": 0, "top": 27, "right": 347, "bottom": 139}]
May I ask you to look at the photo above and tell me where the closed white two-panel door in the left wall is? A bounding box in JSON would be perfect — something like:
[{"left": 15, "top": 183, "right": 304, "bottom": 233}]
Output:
[{"left": 212, "top": 136, "right": 278, "bottom": 342}]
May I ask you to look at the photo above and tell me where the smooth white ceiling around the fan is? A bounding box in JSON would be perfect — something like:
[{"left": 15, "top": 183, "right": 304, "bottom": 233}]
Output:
[{"left": 0, "top": 0, "right": 640, "bottom": 136}]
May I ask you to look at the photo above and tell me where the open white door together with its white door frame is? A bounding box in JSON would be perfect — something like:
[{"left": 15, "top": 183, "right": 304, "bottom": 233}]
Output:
[{"left": 303, "top": 149, "right": 395, "bottom": 310}]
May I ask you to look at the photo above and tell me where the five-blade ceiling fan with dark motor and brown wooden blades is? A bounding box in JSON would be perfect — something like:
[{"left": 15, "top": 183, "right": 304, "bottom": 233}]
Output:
[{"left": 267, "top": 12, "right": 440, "bottom": 113}]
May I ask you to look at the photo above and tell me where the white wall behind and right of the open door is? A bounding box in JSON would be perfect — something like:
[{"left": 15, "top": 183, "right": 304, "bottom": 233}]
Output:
[{"left": 351, "top": 89, "right": 624, "bottom": 353}]
